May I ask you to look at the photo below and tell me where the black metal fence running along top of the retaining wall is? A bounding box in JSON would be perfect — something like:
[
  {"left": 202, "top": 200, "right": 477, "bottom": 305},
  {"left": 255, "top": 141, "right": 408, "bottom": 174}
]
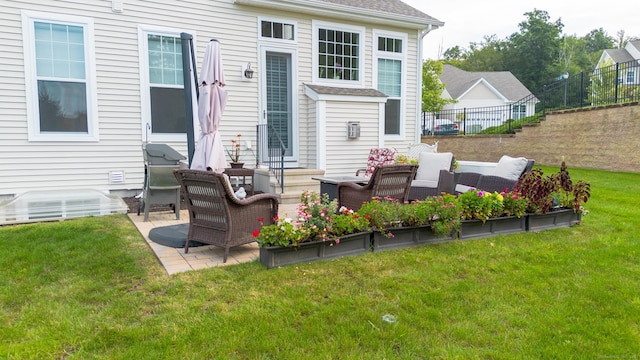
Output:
[{"left": 422, "top": 61, "right": 640, "bottom": 135}]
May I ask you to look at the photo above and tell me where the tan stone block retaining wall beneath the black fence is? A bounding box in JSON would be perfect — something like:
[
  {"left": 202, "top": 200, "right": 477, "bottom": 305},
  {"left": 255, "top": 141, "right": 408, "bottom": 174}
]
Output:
[{"left": 430, "top": 103, "right": 640, "bottom": 172}]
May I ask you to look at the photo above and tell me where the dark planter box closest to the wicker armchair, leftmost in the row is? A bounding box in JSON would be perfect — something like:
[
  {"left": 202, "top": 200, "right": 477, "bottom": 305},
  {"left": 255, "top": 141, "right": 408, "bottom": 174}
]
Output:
[{"left": 260, "top": 232, "right": 371, "bottom": 269}]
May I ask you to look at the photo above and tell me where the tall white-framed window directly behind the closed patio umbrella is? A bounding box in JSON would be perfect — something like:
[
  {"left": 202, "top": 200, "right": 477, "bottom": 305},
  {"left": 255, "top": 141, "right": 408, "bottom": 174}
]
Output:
[{"left": 139, "top": 27, "right": 195, "bottom": 141}]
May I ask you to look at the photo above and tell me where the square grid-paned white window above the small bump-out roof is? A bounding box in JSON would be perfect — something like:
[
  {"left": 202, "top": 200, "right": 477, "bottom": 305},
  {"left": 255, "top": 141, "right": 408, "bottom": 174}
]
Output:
[{"left": 313, "top": 22, "right": 364, "bottom": 86}]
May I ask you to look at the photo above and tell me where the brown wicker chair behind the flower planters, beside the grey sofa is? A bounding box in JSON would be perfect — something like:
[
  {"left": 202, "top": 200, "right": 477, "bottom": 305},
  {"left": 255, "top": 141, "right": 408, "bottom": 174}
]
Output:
[{"left": 338, "top": 165, "right": 418, "bottom": 211}]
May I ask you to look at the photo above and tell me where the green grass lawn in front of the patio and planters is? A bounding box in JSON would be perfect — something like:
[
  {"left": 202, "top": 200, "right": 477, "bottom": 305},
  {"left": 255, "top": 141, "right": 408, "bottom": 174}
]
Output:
[{"left": 0, "top": 168, "right": 640, "bottom": 359}]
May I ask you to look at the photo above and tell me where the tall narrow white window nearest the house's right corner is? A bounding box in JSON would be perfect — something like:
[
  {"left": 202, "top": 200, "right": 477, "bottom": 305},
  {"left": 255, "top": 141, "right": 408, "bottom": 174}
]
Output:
[{"left": 374, "top": 32, "right": 407, "bottom": 136}]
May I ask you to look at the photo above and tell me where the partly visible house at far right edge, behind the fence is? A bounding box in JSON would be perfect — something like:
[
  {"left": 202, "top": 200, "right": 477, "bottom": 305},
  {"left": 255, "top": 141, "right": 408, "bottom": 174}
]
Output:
[{"left": 596, "top": 40, "right": 640, "bottom": 85}]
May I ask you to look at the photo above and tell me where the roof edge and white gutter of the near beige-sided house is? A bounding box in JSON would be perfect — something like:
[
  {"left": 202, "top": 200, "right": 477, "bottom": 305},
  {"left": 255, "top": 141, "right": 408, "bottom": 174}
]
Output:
[{"left": 234, "top": 0, "right": 444, "bottom": 29}]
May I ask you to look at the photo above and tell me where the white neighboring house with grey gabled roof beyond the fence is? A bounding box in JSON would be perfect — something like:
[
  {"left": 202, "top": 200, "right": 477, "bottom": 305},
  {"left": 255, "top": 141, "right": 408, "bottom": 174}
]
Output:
[{"left": 440, "top": 64, "right": 538, "bottom": 128}]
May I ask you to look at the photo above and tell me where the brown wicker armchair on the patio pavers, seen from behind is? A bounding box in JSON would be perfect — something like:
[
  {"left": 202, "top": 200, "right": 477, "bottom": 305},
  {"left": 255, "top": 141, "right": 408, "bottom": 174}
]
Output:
[{"left": 174, "top": 169, "right": 278, "bottom": 262}]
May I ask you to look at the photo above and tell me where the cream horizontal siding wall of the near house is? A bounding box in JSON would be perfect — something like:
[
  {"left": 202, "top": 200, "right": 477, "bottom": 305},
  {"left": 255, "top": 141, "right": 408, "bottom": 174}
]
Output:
[{"left": 0, "top": 0, "right": 430, "bottom": 197}]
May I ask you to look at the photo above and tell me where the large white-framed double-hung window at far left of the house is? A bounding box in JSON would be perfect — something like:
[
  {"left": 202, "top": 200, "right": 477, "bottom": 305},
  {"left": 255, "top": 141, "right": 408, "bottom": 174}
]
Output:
[{"left": 22, "top": 11, "right": 98, "bottom": 141}]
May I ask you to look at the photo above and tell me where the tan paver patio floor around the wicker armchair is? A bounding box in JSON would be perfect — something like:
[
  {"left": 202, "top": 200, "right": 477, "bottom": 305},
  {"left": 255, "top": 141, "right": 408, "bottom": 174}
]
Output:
[{"left": 129, "top": 204, "right": 297, "bottom": 275}]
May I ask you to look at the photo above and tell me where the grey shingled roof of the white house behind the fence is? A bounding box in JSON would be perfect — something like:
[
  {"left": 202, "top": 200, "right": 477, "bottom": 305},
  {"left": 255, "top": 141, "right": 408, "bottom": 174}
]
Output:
[{"left": 440, "top": 64, "right": 531, "bottom": 102}]
